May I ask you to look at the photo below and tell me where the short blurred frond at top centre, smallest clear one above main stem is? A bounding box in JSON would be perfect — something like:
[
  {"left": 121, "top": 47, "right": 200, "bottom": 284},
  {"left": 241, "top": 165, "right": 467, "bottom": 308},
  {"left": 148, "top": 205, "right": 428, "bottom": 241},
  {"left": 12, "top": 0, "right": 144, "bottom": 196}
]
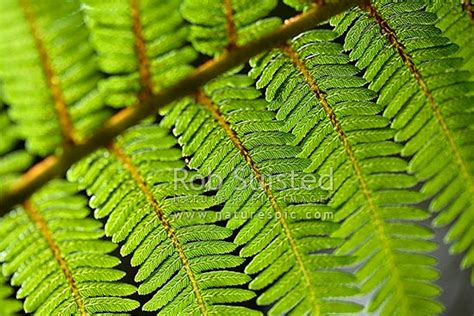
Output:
[{"left": 181, "top": 0, "right": 281, "bottom": 55}]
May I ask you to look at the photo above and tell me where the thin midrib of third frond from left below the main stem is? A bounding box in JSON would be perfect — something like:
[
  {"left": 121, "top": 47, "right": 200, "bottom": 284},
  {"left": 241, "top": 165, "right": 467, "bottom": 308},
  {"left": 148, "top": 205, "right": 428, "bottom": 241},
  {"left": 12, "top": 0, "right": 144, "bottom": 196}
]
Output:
[{"left": 196, "top": 91, "right": 321, "bottom": 316}]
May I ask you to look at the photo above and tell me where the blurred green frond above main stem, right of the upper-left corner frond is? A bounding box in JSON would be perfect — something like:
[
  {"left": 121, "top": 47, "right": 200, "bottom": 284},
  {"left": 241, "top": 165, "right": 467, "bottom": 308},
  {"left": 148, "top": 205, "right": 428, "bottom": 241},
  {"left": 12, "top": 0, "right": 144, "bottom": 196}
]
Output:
[{"left": 84, "top": 0, "right": 196, "bottom": 107}]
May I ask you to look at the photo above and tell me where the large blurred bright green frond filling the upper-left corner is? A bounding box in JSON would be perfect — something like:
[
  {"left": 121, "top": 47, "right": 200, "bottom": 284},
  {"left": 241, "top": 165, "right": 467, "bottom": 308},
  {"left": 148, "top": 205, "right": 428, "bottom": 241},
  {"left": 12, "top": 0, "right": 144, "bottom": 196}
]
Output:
[{"left": 0, "top": 0, "right": 108, "bottom": 155}]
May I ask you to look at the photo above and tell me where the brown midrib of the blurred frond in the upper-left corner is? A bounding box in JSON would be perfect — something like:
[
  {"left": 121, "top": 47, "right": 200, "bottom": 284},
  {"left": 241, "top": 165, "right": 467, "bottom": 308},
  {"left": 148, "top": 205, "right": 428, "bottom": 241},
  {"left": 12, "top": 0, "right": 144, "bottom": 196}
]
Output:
[{"left": 20, "top": 0, "right": 77, "bottom": 147}]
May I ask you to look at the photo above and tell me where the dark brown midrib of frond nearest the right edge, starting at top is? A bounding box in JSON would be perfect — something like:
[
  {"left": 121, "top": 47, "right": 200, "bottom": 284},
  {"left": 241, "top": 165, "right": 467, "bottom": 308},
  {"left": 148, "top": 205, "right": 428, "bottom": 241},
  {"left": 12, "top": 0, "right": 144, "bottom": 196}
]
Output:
[{"left": 363, "top": 3, "right": 474, "bottom": 194}]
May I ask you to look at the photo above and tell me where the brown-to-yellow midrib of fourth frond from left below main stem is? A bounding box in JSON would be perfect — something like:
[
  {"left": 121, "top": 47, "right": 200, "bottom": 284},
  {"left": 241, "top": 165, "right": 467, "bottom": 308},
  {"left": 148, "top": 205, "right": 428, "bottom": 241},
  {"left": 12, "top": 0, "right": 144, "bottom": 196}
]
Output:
[{"left": 282, "top": 44, "right": 410, "bottom": 315}]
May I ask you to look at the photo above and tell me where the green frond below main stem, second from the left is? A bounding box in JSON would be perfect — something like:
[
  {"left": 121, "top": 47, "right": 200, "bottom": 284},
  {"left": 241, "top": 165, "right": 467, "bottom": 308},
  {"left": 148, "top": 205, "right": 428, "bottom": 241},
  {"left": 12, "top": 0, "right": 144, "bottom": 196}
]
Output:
[{"left": 69, "top": 125, "right": 256, "bottom": 315}]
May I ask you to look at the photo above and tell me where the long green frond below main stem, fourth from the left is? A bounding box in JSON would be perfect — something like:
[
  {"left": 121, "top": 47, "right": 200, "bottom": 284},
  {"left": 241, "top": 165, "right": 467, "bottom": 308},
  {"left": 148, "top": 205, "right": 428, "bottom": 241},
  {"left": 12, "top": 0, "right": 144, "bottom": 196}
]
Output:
[{"left": 251, "top": 30, "right": 442, "bottom": 315}]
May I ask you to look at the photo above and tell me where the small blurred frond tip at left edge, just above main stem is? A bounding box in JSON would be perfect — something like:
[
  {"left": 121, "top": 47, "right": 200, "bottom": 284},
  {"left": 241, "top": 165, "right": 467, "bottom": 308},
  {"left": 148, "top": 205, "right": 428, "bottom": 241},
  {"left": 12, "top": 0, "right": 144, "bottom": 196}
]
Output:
[{"left": 0, "top": 94, "right": 33, "bottom": 193}]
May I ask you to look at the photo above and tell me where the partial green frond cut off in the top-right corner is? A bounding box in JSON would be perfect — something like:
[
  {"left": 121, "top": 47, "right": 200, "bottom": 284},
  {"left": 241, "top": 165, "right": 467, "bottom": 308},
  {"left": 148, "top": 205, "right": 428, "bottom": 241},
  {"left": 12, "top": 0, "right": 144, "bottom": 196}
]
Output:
[{"left": 427, "top": 0, "right": 474, "bottom": 80}]
